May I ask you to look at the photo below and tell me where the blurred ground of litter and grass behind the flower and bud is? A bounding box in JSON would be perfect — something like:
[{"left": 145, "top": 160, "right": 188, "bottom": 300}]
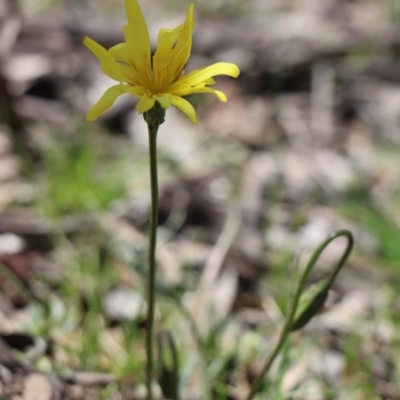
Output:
[{"left": 0, "top": 0, "right": 400, "bottom": 400}]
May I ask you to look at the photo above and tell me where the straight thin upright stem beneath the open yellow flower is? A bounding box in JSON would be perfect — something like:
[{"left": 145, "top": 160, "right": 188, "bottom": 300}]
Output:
[{"left": 146, "top": 123, "right": 159, "bottom": 400}]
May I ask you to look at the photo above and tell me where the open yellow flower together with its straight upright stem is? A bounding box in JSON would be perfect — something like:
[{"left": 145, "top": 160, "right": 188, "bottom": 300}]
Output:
[{"left": 84, "top": 0, "right": 239, "bottom": 400}]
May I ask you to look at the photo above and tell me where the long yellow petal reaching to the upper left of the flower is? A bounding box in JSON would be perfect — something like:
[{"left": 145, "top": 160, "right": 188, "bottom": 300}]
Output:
[{"left": 83, "top": 36, "right": 131, "bottom": 82}]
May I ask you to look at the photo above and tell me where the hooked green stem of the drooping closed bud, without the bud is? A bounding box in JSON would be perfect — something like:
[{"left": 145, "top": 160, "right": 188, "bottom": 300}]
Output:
[{"left": 246, "top": 229, "right": 354, "bottom": 400}]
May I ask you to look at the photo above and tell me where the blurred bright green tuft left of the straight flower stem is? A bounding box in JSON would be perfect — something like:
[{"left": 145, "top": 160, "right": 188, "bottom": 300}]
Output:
[{"left": 39, "top": 127, "right": 125, "bottom": 216}]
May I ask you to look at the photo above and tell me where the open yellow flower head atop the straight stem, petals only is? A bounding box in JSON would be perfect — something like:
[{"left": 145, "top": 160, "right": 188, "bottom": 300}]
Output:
[{"left": 84, "top": 0, "right": 239, "bottom": 123}]
